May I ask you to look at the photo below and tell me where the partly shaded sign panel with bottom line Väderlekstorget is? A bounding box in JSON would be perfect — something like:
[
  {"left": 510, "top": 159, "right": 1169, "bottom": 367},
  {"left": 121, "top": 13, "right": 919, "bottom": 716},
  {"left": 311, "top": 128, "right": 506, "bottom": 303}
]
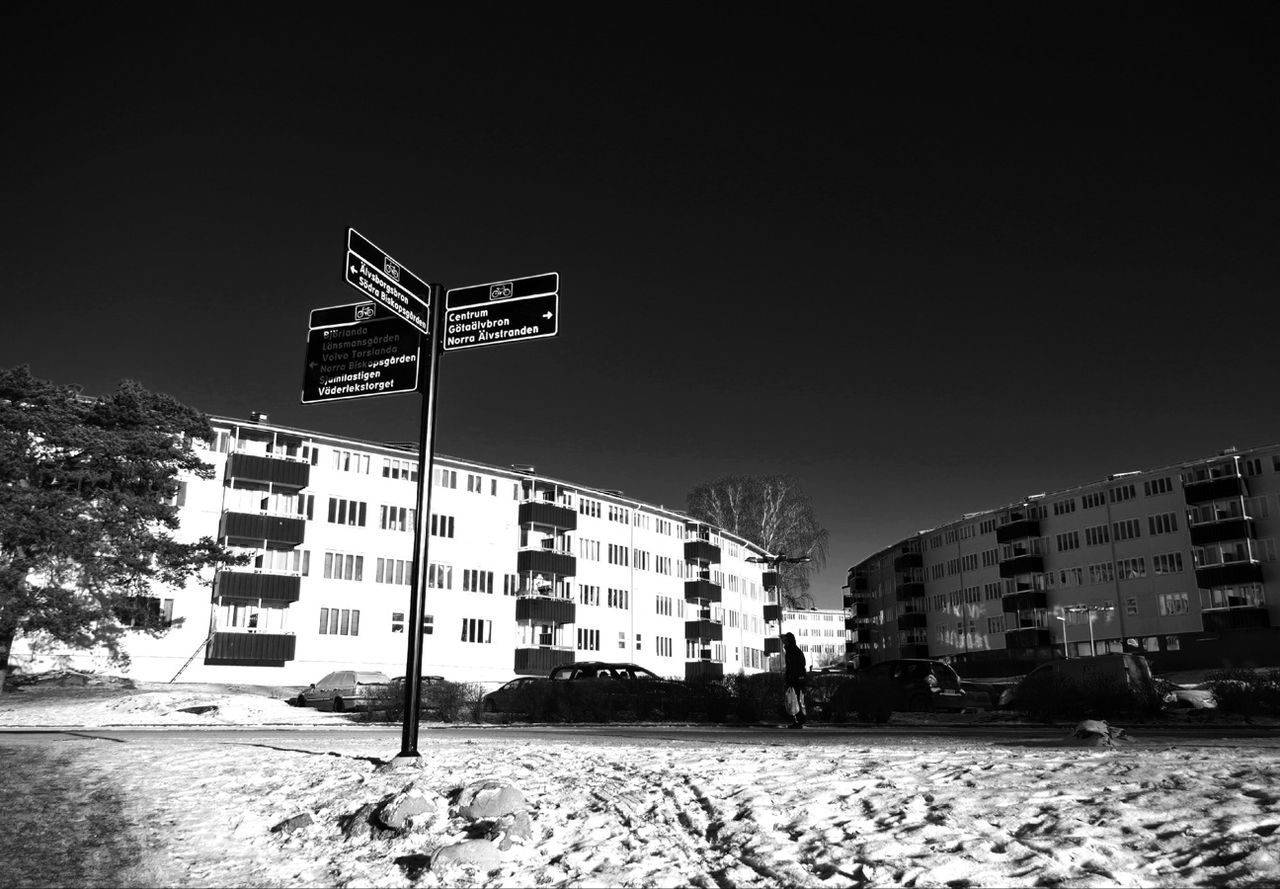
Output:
[{"left": 302, "top": 302, "right": 422, "bottom": 404}]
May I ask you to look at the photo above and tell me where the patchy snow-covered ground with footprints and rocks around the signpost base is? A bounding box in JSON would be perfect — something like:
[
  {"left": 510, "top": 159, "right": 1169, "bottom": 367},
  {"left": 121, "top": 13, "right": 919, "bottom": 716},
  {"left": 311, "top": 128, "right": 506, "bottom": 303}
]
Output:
[{"left": 0, "top": 688, "right": 1280, "bottom": 886}]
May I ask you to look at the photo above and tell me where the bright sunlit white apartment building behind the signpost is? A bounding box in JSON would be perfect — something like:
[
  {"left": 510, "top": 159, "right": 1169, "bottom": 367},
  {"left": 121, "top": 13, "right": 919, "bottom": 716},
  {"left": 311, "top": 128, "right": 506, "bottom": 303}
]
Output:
[{"left": 14, "top": 414, "right": 780, "bottom": 684}]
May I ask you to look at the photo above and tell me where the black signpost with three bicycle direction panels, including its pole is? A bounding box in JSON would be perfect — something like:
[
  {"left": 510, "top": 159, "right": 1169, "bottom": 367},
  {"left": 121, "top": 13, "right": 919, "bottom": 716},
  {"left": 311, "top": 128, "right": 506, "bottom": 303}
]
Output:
[{"left": 302, "top": 229, "right": 559, "bottom": 761}]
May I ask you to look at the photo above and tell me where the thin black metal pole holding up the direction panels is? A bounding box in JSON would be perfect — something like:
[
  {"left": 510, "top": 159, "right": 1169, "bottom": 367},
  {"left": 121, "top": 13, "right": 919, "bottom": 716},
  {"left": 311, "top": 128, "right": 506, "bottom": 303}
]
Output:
[{"left": 399, "top": 284, "right": 444, "bottom": 757}]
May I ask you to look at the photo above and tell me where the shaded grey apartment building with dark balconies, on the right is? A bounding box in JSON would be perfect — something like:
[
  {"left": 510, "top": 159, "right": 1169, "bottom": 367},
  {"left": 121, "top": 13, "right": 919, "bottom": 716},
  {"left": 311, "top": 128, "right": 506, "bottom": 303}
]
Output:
[{"left": 845, "top": 445, "right": 1280, "bottom": 669}]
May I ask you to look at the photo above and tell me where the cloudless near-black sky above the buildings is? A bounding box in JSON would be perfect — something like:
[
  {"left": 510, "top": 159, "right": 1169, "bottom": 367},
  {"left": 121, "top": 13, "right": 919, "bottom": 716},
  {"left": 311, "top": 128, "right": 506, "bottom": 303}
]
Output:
[{"left": 0, "top": 3, "right": 1280, "bottom": 606}]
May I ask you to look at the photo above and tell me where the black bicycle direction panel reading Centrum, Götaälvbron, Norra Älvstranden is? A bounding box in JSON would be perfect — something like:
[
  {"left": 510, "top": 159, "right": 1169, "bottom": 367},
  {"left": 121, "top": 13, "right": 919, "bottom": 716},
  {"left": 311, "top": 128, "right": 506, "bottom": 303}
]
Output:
[{"left": 444, "top": 271, "right": 559, "bottom": 352}]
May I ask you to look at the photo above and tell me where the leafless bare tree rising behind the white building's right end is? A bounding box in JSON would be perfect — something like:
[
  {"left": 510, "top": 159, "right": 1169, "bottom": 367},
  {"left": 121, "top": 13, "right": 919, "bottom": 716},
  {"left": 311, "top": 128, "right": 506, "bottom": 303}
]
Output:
[{"left": 686, "top": 475, "right": 828, "bottom": 608}]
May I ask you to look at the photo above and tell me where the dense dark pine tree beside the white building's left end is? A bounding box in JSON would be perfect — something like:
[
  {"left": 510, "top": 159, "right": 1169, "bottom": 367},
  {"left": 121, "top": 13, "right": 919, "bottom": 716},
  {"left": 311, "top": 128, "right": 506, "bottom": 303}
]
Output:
[{"left": 0, "top": 366, "right": 238, "bottom": 688}]
